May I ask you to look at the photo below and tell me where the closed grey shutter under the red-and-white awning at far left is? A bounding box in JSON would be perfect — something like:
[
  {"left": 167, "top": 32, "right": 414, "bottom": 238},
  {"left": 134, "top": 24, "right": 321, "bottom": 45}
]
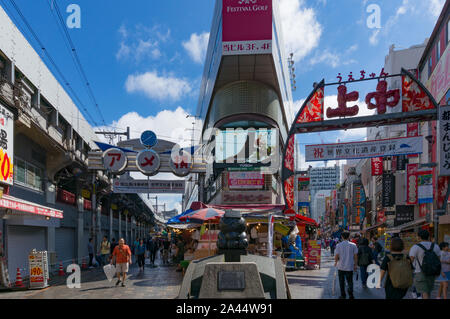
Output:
[{"left": 7, "top": 226, "right": 47, "bottom": 281}]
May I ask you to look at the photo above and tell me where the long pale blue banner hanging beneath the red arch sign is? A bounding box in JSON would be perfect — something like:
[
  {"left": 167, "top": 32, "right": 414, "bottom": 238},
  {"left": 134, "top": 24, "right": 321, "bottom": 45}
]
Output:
[{"left": 305, "top": 136, "right": 423, "bottom": 162}]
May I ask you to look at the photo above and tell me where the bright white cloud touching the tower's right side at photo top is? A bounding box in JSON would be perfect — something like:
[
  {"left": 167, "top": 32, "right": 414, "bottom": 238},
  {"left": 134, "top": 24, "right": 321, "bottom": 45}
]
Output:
[{"left": 280, "top": 0, "right": 322, "bottom": 61}]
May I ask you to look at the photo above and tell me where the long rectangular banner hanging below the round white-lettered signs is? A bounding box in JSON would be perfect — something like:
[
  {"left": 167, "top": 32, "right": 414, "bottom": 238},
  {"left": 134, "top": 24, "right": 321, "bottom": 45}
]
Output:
[{"left": 113, "top": 179, "right": 186, "bottom": 194}]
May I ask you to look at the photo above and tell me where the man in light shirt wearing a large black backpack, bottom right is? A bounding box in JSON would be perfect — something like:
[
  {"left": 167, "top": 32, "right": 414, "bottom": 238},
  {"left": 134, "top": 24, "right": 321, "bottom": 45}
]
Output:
[{"left": 409, "top": 229, "right": 441, "bottom": 299}]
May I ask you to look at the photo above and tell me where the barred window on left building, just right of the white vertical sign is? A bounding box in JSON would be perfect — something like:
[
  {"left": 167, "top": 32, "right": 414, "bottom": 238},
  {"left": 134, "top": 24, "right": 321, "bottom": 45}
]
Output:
[{"left": 14, "top": 158, "right": 44, "bottom": 191}]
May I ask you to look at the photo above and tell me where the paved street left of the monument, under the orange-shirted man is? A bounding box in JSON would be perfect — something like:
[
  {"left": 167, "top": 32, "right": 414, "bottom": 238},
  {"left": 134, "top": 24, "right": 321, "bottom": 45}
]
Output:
[{"left": 0, "top": 261, "right": 182, "bottom": 299}]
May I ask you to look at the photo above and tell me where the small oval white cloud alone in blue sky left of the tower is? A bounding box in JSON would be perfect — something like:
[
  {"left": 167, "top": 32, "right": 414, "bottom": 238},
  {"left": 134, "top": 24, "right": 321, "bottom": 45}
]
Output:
[{"left": 125, "top": 71, "right": 192, "bottom": 101}]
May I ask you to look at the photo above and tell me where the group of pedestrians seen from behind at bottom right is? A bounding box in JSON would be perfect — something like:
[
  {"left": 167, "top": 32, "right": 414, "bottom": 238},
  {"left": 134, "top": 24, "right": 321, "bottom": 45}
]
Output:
[{"left": 330, "top": 230, "right": 450, "bottom": 299}]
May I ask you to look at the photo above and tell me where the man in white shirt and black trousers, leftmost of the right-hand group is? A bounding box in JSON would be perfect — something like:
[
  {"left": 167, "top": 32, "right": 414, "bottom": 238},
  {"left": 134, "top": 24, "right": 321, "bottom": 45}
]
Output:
[{"left": 334, "top": 232, "right": 358, "bottom": 299}]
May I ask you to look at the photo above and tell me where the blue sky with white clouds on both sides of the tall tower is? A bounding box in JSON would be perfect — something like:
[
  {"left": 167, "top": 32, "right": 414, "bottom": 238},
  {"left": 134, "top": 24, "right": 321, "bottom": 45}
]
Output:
[{"left": 0, "top": 0, "right": 444, "bottom": 212}]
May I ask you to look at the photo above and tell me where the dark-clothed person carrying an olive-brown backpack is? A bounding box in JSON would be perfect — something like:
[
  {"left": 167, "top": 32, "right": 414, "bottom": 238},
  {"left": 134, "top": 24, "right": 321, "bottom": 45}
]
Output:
[{"left": 376, "top": 237, "right": 413, "bottom": 299}]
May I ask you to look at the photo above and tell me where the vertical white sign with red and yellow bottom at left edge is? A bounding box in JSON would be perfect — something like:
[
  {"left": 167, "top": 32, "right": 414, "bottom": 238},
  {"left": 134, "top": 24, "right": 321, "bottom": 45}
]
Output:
[{"left": 0, "top": 104, "right": 14, "bottom": 185}]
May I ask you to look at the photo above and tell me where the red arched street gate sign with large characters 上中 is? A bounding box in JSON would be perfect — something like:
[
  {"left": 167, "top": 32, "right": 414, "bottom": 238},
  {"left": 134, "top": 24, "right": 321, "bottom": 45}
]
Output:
[{"left": 281, "top": 69, "right": 439, "bottom": 209}]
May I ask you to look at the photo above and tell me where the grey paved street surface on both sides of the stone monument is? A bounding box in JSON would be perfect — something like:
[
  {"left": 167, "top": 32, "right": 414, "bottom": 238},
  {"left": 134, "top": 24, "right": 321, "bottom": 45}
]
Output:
[{"left": 0, "top": 250, "right": 438, "bottom": 299}]
